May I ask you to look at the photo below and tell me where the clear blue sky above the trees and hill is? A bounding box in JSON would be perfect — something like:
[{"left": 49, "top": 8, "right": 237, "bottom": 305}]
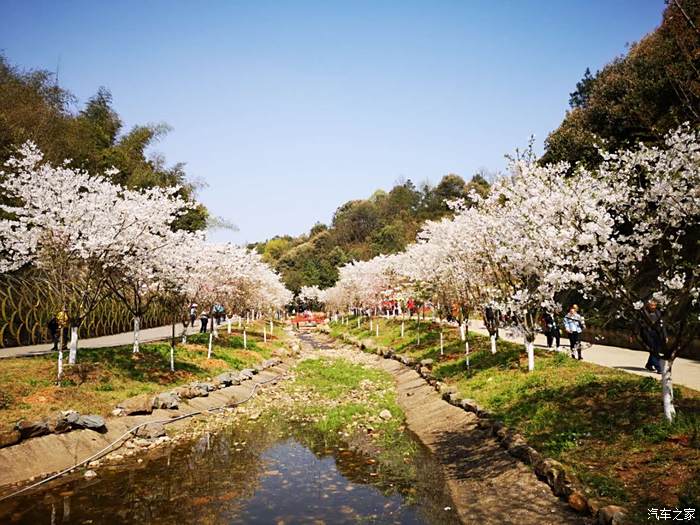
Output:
[{"left": 0, "top": 0, "right": 664, "bottom": 242}]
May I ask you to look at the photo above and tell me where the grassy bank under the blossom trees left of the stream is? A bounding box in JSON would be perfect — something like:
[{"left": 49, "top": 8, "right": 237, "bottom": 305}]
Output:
[{"left": 0, "top": 323, "right": 285, "bottom": 430}]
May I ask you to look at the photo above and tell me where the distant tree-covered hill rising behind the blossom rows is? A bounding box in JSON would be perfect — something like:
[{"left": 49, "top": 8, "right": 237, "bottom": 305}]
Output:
[{"left": 250, "top": 174, "right": 489, "bottom": 292}]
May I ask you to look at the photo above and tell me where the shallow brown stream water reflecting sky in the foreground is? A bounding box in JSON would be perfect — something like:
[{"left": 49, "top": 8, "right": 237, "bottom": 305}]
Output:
[{"left": 0, "top": 416, "right": 459, "bottom": 525}]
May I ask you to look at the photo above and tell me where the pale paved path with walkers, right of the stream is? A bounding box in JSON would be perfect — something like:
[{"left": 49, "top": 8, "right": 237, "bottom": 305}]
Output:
[{"left": 469, "top": 321, "right": 700, "bottom": 390}]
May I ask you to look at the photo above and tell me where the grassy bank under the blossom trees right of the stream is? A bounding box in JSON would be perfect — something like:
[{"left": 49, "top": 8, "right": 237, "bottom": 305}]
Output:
[{"left": 331, "top": 319, "right": 700, "bottom": 512}]
